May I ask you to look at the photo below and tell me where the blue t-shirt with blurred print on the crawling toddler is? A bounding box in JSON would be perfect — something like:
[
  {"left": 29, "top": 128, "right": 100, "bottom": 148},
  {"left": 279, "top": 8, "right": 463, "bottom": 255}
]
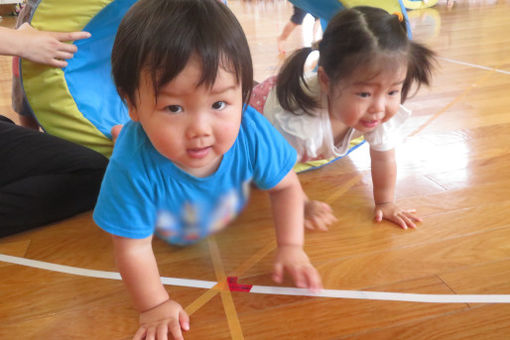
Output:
[{"left": 94, "top": 107, "right": 297, "bottom": 245}]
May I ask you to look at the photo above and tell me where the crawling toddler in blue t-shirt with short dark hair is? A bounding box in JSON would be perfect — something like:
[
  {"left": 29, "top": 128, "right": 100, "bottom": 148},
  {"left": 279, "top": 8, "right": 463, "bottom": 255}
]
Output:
[{"left": 94, "top": 0, "right": 321, "bottom": 339}]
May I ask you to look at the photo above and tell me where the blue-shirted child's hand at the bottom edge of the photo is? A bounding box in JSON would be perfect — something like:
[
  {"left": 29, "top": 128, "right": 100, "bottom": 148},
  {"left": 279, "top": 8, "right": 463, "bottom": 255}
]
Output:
[{"left": 133, "top": 299, "right": 189, "bottom": 340}]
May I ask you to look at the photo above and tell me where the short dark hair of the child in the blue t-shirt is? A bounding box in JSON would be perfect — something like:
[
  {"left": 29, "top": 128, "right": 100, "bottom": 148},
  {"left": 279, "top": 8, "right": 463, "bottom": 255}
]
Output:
[{"left": 112, "top": 0, "right": 253, "bottom": 105}]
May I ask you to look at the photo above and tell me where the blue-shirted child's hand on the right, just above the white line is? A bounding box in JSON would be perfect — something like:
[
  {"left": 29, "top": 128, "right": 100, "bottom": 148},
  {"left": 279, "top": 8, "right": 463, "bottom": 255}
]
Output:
[{"left": 273, "top": 245, "right": 322, "bottom": 291}]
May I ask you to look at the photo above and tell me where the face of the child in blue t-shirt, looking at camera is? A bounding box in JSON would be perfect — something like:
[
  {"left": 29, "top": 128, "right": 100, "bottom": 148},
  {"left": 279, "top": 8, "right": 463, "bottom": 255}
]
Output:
[{"left": 128, "top": 57, "right": 243, "bottom": 177}]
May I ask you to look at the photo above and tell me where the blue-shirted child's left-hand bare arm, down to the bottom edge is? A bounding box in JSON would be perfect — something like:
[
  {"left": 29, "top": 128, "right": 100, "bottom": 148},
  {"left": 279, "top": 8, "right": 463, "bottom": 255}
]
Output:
[{"left": 113, "top": 236, "right": 189, "bottom": 340}]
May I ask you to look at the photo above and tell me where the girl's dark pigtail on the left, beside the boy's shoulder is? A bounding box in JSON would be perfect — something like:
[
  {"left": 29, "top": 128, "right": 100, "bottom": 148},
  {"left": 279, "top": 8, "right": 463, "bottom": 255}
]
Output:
[{"left": 276, "top": 47, "right": 318, "bottom": 115}]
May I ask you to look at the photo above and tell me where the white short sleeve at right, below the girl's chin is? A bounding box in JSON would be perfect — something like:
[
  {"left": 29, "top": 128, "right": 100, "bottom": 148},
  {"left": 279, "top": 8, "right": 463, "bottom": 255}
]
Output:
[{"left": 364, "top": 105, "right": 411, "bottom": 151}]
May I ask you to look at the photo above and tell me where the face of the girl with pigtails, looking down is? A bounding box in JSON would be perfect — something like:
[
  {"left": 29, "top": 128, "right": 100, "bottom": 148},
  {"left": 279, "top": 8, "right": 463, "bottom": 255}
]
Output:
[{"left": 319, "top": 66, "right": 407, "bottom": 132}]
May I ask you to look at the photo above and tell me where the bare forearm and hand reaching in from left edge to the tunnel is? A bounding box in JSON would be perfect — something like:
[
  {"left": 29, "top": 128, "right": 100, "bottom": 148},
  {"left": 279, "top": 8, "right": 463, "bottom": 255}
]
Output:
[{"left": 0, "top": 23, "right": 90, "bottom": 67}]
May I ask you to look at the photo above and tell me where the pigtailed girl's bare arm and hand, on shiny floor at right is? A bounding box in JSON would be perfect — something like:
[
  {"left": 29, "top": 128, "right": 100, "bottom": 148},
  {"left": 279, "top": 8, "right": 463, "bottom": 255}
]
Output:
[{"left": 370, "top": 149, "right": 421, "bottom": 229}]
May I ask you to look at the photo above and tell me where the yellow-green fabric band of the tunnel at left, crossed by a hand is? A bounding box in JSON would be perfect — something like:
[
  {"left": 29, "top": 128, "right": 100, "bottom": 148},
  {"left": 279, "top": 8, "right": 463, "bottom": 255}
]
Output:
[{"left": 21, "top": 0, "right": 113, "bottom": 157}]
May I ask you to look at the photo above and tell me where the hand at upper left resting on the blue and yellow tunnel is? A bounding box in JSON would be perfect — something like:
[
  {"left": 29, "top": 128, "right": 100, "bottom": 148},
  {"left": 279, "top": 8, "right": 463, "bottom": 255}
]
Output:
[{"left": 17, "top": 23, "right": 90, "bottom": 67}]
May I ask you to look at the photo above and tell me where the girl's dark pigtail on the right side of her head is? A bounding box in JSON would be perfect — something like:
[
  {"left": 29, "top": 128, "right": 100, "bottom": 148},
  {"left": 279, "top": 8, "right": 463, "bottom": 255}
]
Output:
[{"left": 402, "top": 41, "right": 436, "bottom": 103}]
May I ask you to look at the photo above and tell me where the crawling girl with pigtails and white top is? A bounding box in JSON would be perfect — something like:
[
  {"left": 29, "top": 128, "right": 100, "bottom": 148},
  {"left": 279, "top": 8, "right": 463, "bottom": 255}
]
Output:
[{"left": 250, "top": 7, "right": 434, "bottom": 229}]
